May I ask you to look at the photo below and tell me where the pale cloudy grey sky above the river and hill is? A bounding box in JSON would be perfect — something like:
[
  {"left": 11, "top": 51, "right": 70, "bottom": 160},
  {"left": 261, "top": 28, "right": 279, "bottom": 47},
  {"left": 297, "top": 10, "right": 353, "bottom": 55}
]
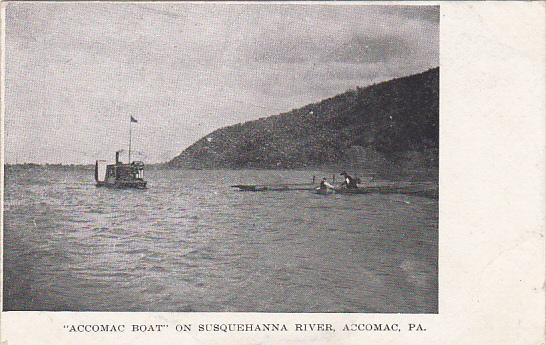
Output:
[{"left": 4, "top": 2, "right": 440, "bottom": 164}]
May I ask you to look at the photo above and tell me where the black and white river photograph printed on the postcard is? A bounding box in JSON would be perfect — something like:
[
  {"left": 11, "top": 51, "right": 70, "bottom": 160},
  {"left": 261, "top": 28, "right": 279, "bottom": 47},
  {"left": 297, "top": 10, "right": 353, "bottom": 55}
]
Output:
[{"left": 3, "top": 2, "right": 441, "bottom": 314}]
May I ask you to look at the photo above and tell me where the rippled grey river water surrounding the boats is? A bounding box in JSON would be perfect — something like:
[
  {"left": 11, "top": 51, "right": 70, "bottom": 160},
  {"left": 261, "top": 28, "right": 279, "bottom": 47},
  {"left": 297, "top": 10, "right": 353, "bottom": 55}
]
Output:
[{"left": 4, "top": 168, "right": 438, "bottom": 313}]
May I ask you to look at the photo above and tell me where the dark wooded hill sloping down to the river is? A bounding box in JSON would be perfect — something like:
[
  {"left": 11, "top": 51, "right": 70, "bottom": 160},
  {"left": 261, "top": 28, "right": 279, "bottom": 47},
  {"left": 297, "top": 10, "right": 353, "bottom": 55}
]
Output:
[{"left": 168, "top": 68, "right": 439, "bottom": 169}]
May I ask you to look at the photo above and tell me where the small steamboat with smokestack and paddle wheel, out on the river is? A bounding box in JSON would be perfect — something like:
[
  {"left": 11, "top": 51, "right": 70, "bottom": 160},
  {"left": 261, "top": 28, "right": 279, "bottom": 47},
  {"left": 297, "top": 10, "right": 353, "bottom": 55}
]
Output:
[{"left": 95, "top": 151, "right": 147, "bottom": 189}]
